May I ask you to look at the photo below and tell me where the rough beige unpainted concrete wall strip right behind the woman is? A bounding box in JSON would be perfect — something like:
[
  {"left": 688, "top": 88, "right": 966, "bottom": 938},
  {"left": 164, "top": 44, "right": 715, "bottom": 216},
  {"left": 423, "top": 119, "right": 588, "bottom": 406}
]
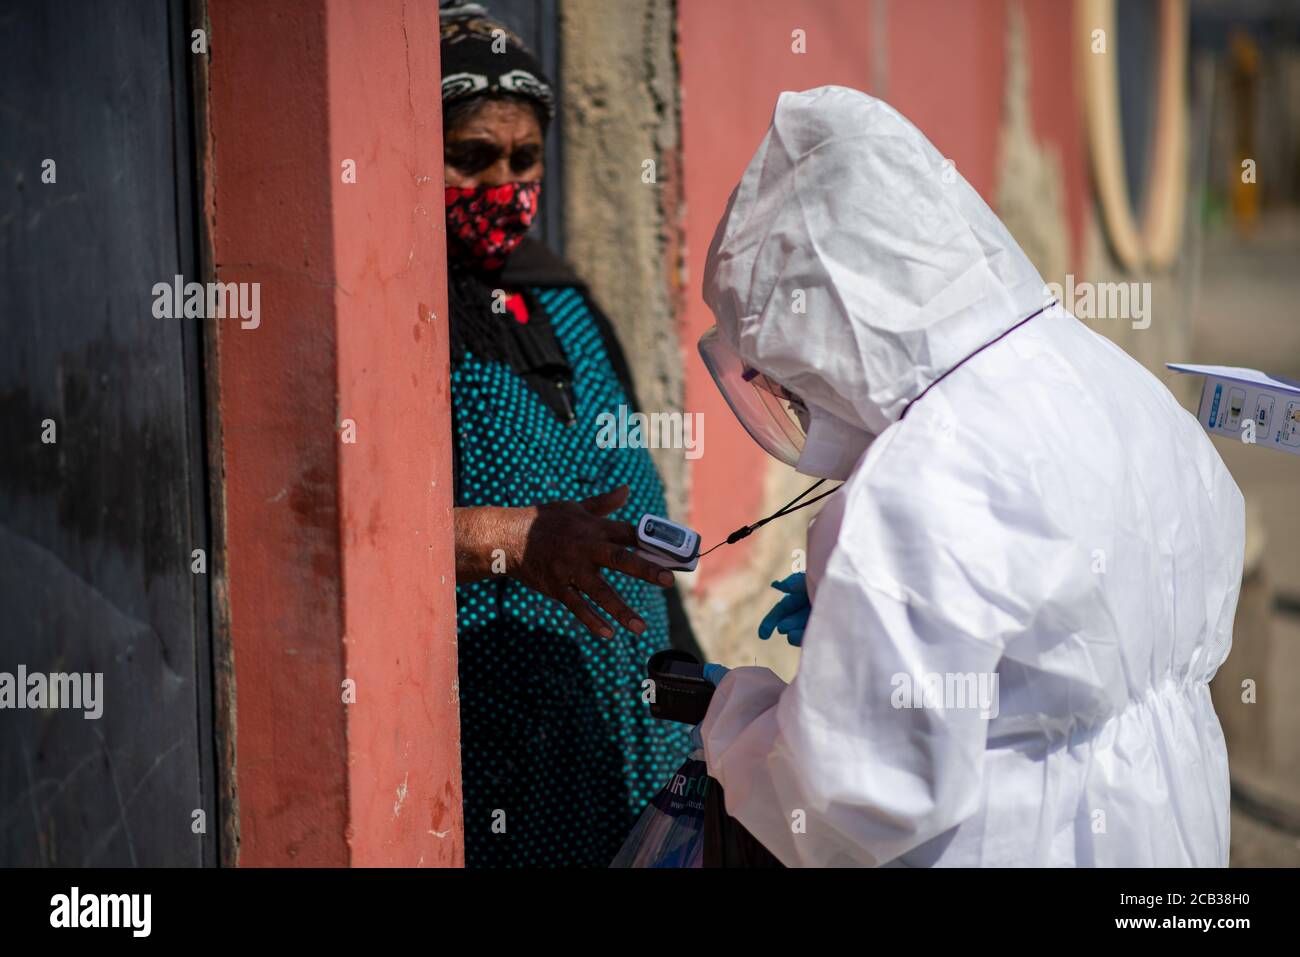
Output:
[{"left": 560, "top": 0, "right": 688, "bottom": 519}]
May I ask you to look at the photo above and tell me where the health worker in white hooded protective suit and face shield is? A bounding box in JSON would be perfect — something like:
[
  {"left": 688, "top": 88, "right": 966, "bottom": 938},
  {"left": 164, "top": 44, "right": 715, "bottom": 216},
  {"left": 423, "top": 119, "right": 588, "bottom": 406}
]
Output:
[{"left": 701, "top": 87, "right": 1244, "bottom": 866}]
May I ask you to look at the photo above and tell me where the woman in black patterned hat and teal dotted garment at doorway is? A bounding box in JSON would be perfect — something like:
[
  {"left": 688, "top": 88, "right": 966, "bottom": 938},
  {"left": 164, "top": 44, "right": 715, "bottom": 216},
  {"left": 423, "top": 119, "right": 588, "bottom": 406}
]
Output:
[{"left": 441, "top": 5, "right": 694, "bottom": 867}]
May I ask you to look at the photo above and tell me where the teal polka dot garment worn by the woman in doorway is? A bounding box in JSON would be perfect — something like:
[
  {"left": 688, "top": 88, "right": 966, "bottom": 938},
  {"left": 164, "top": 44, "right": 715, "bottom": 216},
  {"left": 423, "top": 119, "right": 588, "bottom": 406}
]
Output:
[{"left": 451, "top": 289, "right": 690, "bottom": 867}]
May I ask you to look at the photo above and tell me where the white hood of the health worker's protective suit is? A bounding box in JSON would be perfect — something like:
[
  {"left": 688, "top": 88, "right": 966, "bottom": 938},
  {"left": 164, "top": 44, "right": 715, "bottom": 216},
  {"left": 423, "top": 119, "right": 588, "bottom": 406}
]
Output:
[{"left": 703, "top": 86, "right": 1047, "bottom": 434}]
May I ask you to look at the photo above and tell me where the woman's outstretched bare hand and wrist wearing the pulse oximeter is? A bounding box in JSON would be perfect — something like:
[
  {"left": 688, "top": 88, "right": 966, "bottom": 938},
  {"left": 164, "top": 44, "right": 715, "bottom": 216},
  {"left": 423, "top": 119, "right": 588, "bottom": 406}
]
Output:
[{"left": 456, "top": 485, "right": 673, "bottom": 638}]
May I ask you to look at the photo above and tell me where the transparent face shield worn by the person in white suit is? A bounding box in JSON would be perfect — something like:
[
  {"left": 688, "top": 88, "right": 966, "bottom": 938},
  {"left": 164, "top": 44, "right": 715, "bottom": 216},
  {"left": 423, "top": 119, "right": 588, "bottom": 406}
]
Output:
[{"left": 699, "top": 326, "right": 809, "bottom": 467}]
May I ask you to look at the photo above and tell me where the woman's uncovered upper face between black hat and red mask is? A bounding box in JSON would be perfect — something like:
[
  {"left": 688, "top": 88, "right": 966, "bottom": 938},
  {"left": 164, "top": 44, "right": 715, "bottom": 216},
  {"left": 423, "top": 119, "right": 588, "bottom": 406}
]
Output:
[{"left": 442, "top": 100, "right": 542, "bottom": 187}]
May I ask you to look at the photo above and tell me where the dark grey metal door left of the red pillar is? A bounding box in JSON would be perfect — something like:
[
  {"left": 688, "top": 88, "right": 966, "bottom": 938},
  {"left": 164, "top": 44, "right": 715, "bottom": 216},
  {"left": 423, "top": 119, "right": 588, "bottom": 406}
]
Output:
[{"left": 0, "top": 0, "right": 220, "bottom": 865}]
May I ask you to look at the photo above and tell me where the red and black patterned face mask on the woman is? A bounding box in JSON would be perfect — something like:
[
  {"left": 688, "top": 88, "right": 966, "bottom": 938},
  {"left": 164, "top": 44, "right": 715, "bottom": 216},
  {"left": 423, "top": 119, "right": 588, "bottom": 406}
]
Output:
[{"left": 446, "top": 182, "right": 542, "bottom": 270}]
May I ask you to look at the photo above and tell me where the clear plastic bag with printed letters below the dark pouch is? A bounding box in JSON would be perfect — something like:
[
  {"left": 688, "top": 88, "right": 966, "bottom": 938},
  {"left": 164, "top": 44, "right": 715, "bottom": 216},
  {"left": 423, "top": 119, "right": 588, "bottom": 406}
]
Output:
[{"left": 610, "top": 750, "right": 714, "bottom": 867}]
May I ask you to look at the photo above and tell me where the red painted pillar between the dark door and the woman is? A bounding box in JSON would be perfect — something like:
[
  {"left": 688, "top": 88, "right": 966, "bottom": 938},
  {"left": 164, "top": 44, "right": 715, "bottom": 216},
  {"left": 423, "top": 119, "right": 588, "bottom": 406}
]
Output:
[{"left": 205, "top": 0, "right": 463, "bottom": 866}]
